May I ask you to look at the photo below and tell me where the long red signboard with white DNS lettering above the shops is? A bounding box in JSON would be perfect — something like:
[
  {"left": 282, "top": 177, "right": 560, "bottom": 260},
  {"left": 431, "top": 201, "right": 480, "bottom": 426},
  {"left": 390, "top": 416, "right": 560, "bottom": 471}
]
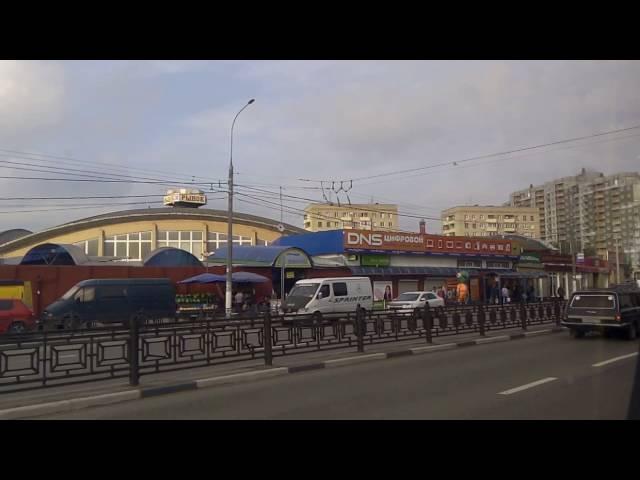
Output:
[{"left": 343, "top": 230, "right": 511, "bottom": 255}]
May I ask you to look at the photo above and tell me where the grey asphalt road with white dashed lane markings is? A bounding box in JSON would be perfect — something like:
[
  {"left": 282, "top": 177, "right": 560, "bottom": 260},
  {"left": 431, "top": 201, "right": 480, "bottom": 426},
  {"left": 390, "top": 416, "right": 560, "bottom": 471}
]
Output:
[{"left": 41, "top": 333, "right": 640, "bottom": 419}]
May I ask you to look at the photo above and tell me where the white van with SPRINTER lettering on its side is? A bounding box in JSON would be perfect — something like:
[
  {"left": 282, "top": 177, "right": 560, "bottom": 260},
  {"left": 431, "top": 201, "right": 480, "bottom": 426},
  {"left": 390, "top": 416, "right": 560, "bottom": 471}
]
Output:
[{"left": 285, "top": 277, "right": 373, "bottom": 317}]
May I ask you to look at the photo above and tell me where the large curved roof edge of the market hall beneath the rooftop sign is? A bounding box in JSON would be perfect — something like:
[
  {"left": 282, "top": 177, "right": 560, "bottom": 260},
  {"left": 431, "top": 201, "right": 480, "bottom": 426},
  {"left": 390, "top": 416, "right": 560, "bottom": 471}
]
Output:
[{"left": 0, "top": 207, "right": 305, "bottom": 254}]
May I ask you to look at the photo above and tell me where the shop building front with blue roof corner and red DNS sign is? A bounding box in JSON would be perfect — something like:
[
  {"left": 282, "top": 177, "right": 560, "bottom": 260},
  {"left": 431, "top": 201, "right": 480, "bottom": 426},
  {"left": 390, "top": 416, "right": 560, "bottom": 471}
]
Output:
[{"left": 274, "top": 230, "right": 518, "bottom": 302}]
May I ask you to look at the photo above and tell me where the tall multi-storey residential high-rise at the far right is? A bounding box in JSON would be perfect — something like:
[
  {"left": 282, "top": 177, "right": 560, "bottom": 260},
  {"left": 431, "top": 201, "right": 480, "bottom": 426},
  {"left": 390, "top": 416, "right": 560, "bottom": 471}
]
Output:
[{"left": 509, "top": 168, "right": 640, "bottom": 267}]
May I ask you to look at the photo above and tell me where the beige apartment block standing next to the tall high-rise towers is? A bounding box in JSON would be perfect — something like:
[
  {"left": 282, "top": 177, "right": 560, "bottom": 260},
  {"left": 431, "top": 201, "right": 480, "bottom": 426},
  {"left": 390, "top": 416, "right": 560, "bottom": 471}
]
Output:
[{"left": 441, "top": 205, "right": 540, "bottom": 239}]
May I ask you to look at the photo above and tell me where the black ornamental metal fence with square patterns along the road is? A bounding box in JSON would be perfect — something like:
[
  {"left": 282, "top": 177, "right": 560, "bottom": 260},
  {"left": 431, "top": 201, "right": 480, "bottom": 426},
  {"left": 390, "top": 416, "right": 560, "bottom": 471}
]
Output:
[{"left": 0, "top": 301, "right": 565, "bottom": 393}]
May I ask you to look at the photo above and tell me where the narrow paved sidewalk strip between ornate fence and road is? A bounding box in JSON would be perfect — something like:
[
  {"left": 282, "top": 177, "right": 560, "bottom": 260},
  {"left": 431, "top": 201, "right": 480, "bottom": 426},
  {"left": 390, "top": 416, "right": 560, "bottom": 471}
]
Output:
[{"left": 0, "top": 324, "right": 559, "bottom": 419}]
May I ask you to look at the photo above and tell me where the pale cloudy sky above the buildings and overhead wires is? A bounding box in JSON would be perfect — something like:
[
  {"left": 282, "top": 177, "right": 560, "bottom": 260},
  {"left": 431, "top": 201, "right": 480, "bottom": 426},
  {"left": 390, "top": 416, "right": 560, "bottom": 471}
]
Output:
[{"left": 0, "top": 60, "right": 640, "bottom": 232}]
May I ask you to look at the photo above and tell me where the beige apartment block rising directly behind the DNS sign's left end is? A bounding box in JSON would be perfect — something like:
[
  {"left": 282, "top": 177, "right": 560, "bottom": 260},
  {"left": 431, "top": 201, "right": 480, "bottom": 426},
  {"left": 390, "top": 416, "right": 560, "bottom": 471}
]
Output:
[{"left": 304, "top": 203, "right": 398, "bottom": 232}]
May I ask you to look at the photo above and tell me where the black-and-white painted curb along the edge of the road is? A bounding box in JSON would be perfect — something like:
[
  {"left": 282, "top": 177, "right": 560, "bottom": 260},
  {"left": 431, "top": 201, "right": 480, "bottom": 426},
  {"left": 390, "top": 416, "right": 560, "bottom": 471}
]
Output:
[{"left": 0, "top": 327, "right": 563, "bottom": 420}]
